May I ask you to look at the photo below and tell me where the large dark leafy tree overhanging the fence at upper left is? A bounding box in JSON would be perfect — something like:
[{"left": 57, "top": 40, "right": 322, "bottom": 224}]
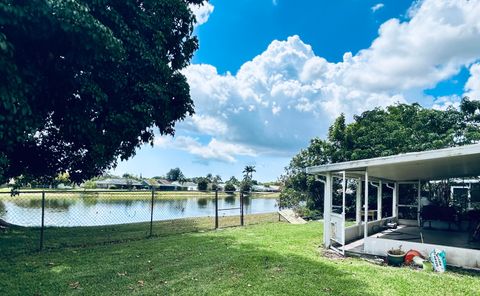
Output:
[{"left": 0, "top": 0, "right": 204, "bottom": 182}]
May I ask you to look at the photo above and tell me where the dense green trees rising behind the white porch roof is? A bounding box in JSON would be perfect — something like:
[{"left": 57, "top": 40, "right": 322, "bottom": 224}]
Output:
[{"left": 281, "top": 98, "right": 480, "bottom": 210}]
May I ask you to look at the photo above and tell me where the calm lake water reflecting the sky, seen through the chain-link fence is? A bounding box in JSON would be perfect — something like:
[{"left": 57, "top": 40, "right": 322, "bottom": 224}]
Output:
[{"left": 0, "top": 196, "right": 278, "bottom": 226}]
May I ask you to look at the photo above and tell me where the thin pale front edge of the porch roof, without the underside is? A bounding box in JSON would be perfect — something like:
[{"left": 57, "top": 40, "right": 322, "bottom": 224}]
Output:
[{"left": 306, "top": 144, "right": 480, "bottom": 174}]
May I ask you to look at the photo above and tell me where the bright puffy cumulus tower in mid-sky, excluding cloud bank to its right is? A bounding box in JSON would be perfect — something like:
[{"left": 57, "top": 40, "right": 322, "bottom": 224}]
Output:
[{"left": 181, "top": 36, "right": 404, "bottom": 154}]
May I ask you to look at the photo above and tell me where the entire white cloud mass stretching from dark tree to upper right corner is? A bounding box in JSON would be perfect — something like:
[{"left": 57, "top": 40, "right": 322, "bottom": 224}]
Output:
[{"left": 178, "top": 0, "right": 480, "bottom": 161}]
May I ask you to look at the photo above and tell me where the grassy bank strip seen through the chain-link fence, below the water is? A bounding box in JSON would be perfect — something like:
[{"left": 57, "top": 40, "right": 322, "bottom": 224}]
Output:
[{"left": 0, "top": 213, "right": 277, "bottom": 258}]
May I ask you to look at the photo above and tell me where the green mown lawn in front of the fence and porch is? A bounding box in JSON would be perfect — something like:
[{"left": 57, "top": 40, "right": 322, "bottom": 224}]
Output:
[{"left": 0, "top": 222, "right": 480, "bottom": 295}]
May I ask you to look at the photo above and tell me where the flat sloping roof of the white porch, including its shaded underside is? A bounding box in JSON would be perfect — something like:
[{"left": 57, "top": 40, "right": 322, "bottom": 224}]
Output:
[{"left": 306, "top": 144, "right": 480, "bottom": 181}]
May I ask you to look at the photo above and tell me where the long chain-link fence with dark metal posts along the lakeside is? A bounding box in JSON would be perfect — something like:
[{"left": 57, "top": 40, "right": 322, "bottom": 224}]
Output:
[{"left": 0, "top": 190, "right": 278, "bottom": 254}]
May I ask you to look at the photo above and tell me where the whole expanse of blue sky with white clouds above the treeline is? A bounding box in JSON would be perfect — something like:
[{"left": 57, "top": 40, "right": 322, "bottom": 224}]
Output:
[{"left": 115, "top": 0, "right": 480, "bottom": 181}]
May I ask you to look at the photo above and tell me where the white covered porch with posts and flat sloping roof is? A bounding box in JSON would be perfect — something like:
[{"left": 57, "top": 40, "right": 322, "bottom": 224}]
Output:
[{"left": 306, "top": 144, "right": 480, "bottom": 268}]
